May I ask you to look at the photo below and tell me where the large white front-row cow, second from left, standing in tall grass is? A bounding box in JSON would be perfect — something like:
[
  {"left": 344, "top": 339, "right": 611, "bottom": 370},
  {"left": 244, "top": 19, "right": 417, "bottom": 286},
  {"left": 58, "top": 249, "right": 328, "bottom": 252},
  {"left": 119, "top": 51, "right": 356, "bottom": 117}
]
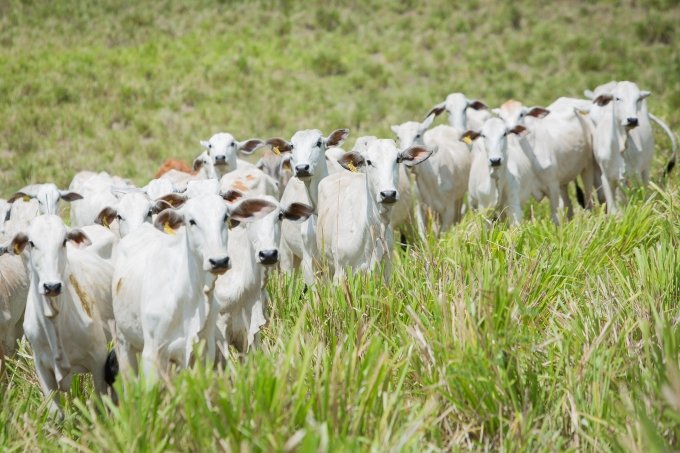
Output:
[{"left": 112, "top": 194, "right": 276, "bottom": 382}]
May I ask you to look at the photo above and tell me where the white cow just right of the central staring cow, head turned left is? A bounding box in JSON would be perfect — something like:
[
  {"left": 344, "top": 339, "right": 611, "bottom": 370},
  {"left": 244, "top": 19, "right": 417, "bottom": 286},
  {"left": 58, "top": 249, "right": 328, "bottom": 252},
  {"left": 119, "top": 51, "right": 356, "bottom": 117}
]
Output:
[{"left": 392, "top": 114, "right": 472, "bottom": 234}]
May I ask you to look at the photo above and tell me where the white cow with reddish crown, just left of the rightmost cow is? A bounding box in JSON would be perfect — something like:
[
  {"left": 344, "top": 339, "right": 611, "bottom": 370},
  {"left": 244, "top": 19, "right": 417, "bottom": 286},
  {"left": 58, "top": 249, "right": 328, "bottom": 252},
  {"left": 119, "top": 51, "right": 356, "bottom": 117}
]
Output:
[{"left": 494, "top": 98, "right": 595, "bottom": 221}]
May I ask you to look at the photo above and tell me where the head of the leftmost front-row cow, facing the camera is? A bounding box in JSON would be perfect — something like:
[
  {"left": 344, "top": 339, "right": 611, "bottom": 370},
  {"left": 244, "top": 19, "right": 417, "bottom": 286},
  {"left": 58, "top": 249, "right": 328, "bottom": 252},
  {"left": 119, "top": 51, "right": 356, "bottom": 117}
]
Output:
[{"left": 0, "top": 214, "right": 90, "bottom": 318}]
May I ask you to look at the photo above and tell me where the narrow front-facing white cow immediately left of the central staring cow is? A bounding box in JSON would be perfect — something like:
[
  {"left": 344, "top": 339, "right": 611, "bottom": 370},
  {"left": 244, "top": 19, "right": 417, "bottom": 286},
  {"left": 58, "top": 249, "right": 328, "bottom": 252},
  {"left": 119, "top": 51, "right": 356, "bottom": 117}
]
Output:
[{"left": 267, "top": 129, "right": 349, "bottom": 285}]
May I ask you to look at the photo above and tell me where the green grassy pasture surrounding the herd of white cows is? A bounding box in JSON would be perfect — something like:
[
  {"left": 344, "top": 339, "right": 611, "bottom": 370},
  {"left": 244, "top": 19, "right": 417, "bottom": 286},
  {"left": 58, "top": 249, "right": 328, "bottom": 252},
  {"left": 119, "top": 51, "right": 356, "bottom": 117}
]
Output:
[{"left": 0, "top": 0, "right": 680, "bottom": 452}]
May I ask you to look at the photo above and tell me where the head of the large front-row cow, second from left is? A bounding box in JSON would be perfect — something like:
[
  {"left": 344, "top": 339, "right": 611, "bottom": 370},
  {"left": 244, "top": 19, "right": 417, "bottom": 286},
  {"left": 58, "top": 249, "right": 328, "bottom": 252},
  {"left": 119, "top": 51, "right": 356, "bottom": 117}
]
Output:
[{"left": 154, "top": 194, "right": 277, "bottom": 274}]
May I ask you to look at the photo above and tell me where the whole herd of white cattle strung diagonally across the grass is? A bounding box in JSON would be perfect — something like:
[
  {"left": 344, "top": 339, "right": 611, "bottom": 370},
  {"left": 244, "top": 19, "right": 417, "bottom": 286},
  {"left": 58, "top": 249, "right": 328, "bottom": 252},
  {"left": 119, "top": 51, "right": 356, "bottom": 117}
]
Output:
[{"left": 0, "top": 82, "right": 676, "bottom": 415}]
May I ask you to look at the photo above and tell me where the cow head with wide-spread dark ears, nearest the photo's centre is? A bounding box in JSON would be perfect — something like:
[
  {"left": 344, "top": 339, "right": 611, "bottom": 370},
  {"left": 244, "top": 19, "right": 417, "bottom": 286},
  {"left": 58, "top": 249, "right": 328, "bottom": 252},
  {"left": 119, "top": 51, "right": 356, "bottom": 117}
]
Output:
[{"left": 338, "top": 139, "right": 432, "bottom": 204}]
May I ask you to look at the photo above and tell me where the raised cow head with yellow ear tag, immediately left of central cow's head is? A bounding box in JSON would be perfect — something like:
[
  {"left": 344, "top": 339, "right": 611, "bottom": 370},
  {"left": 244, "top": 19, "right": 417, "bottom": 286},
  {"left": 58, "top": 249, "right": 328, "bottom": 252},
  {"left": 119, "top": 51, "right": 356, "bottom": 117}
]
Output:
[{"left": 267, "top": 129, "right": 349, "bottom": 181}]
